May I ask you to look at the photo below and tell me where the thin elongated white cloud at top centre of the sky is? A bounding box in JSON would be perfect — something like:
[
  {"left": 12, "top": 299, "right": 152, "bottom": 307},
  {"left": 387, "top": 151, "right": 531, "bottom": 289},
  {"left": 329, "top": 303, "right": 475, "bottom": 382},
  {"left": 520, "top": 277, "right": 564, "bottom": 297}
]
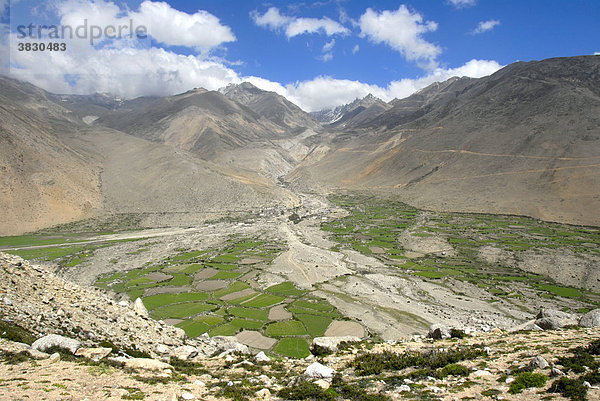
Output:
[{"left": 250, "top": 7, "right": 350, "bottom": 38}]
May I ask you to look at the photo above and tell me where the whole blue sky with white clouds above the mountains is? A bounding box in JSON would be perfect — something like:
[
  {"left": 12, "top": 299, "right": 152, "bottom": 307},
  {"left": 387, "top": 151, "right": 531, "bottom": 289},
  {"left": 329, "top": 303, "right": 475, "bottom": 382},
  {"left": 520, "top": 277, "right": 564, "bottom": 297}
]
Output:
[{"left": 0, "top": 0, "right": 600, "bottom": 111}]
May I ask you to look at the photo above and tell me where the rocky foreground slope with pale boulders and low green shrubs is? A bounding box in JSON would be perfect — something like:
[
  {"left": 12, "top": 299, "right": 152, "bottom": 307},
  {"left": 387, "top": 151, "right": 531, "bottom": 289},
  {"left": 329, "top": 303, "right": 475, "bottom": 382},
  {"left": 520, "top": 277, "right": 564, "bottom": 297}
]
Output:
[{"left": 0, "top": 253, "right": 600, "bottom": 401}]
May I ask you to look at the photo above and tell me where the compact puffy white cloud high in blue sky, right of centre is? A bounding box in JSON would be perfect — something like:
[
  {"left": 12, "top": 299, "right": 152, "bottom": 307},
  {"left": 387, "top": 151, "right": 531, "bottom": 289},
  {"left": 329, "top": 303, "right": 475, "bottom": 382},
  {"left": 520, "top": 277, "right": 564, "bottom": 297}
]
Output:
[{"left": 358, "top": 5, "right": 441, "bottom": 68}]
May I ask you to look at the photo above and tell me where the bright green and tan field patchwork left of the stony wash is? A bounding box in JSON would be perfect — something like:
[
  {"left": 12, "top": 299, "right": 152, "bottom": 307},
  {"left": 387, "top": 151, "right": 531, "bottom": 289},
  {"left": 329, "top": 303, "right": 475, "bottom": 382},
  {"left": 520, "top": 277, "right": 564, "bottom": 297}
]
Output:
[{"left": 96, "top": 234, "right": 342, "bottom": 357}]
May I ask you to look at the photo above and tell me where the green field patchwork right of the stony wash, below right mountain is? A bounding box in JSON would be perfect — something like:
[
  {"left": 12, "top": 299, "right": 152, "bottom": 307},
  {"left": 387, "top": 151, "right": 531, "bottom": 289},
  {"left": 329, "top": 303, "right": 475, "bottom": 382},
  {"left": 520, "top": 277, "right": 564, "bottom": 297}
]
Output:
[{"left": 321, "top": 195, "right": 600, "bottom": 310}]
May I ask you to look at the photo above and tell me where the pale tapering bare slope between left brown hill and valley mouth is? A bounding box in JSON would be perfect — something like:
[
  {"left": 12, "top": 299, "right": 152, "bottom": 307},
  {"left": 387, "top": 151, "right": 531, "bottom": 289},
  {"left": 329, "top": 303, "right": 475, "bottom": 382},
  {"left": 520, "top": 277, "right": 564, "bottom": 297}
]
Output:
[{"left": 66, "top": 127, "right": 296, "bottom": 226}]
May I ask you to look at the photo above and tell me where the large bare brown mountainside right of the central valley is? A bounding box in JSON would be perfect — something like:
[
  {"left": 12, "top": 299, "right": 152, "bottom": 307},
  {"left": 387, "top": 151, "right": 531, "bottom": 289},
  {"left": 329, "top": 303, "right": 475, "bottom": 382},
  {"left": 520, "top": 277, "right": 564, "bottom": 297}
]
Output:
[{"left": 289, "top": 56, "right": 600, "bottom": 225}]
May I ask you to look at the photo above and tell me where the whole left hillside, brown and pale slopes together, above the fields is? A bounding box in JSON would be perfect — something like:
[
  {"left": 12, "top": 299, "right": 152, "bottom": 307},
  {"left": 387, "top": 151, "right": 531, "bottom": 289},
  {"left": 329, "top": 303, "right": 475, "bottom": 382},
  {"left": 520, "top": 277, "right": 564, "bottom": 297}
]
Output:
[{"left": 0, "top": 79, "right": 297, "bottom": 235}]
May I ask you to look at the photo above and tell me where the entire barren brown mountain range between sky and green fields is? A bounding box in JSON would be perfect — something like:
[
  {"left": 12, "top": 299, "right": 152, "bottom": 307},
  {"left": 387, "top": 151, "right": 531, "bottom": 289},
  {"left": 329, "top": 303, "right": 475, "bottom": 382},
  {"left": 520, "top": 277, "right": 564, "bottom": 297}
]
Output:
[{"left": 0, "top": 56, "right": 600, "bottom": 235}]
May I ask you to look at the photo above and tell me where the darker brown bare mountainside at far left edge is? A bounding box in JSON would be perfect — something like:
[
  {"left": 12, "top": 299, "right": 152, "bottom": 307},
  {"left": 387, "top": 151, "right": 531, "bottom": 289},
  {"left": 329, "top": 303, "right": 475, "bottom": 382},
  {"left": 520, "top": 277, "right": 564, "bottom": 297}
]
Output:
[{"left": 0, "top": 78, "right": 101, "bottom": 235}]
